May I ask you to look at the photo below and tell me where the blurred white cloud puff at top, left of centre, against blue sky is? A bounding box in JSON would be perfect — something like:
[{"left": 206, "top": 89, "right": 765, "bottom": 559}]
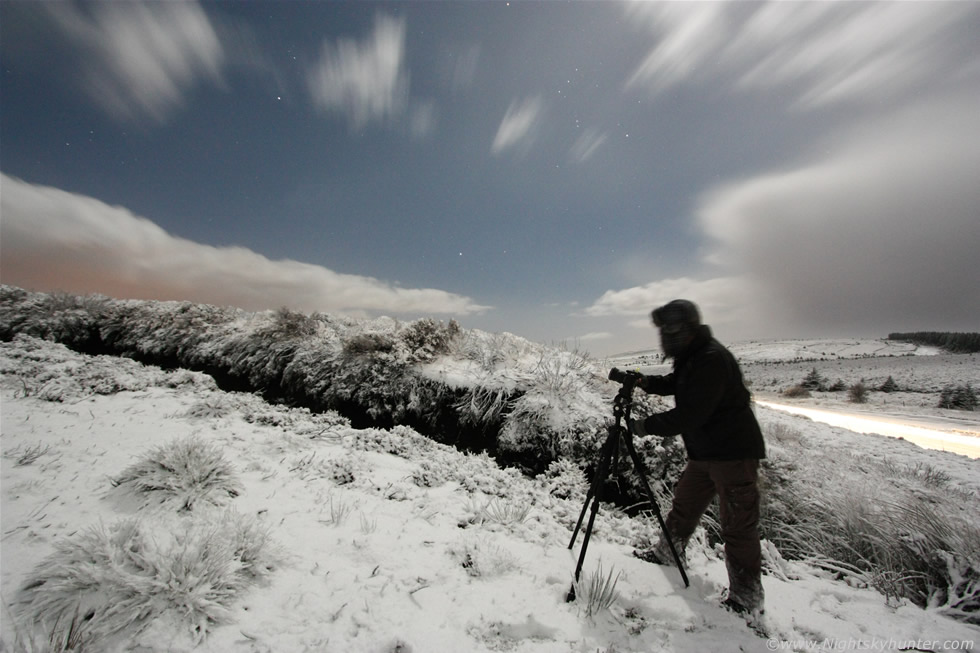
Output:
[{"left": 307, "top": 14, "right": 409, "bottom": 129}]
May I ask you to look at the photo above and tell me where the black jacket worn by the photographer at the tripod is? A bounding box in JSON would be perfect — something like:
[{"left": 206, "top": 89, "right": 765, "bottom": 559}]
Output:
[{"left": 637, "top": 325, "right": 766, "bottom": 460}]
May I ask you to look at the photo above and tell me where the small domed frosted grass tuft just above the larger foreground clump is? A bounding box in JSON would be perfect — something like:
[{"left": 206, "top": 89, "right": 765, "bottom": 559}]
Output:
[{"left": 112, "top": 437, "right": 242, "bottom": 510}]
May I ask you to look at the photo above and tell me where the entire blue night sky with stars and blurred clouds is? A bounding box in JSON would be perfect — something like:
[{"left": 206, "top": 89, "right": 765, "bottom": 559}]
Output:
[{"left": 0, "top": 0, "right": 980, "bottom": 355}]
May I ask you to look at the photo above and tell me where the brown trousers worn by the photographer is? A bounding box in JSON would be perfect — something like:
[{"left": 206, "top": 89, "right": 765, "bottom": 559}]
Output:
[{"left": 666, "top": 459, "right": 763, "bottom": 609}]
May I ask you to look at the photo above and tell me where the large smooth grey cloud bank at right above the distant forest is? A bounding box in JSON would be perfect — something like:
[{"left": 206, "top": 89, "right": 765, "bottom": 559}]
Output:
[{"left": 699, "top": 97, "right": 980, "bottom": 332}]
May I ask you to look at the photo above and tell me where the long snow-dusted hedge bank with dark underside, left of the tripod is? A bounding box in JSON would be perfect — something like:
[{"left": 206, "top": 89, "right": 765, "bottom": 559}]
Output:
[{"left": 0, "top": 286, "right": 678, "bottom": 488}]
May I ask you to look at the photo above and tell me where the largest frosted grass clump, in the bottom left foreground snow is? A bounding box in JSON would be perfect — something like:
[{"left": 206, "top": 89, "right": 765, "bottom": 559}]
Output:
[{"left": 18, "top": 511, "right": 280, "bottom": 650}]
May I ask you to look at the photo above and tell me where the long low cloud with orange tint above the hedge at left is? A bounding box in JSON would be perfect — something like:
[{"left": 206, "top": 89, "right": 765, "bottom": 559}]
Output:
[{"left": 0, "top": 175, "right": 489, "bottom": 315}]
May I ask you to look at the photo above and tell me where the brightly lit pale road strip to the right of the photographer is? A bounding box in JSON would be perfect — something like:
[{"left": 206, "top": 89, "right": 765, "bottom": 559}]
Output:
[{"left": 756, "top": 400, "right": 980, "bottom": 458}]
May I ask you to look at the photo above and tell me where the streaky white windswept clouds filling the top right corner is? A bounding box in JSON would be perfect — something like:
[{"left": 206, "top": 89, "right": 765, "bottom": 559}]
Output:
[{"left": 626, "top": 2, "right": 978, "bottom": 108}]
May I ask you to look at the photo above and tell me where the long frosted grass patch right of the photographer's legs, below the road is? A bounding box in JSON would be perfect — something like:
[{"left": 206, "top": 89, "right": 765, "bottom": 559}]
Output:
[{"left": 763, "top": 422, "right": 980, "bottom": 623}]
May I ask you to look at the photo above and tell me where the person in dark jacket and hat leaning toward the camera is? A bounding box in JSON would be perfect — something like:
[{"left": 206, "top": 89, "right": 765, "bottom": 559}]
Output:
[{"left": 610, "top": 299, "right": 766, "bottom": 615}]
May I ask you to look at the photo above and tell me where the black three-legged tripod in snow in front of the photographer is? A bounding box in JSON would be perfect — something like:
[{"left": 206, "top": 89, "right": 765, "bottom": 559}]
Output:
[{"left": 566, "top": 374, "right": 691, "bottom": 602}]
